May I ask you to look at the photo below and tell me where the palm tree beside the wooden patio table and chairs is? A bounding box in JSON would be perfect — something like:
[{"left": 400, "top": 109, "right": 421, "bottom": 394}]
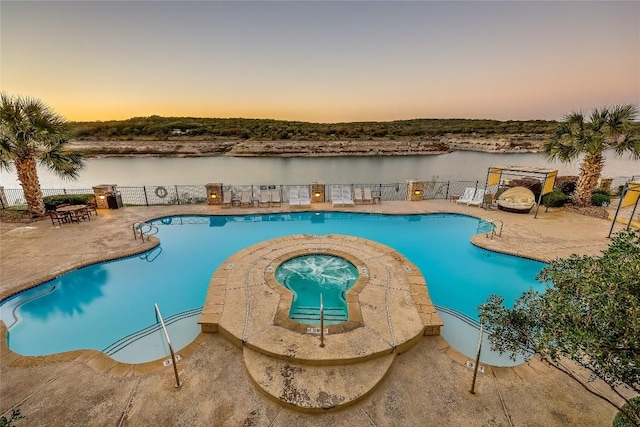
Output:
[{"left": 0, "top": 93, "right": 84, "bottom": 217}]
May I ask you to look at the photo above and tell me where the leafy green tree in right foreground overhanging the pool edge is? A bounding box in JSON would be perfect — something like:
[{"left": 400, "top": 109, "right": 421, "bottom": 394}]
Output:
[{"left": 480, "top": 230, "right": 640, "bottom": 426}]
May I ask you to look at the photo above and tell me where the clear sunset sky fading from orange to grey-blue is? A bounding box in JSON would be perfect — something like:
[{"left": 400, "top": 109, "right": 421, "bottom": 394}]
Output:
[{"left": 0, "top": 0, "right": 640, "bottom": 122}]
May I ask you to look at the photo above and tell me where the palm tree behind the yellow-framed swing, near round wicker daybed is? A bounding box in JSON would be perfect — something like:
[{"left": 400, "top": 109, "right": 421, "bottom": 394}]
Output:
[{"left": 542, "top": 105, "right": 640, "bottom": 206}]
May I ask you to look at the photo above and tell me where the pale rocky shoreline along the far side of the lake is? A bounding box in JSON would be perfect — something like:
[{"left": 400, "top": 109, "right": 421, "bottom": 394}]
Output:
[{"left": 69, "top": 135, "right": 547, "bottom": 157}]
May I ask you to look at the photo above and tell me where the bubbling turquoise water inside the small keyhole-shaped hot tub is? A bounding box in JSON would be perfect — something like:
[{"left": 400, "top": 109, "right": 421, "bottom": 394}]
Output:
[{"left": 276, "top": 254, "right": 358, "bottom": 325}]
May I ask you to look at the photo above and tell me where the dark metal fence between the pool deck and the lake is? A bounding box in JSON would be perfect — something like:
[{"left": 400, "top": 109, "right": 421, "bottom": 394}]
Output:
[{"left": 2, "top": 175, "right": 640, "bottom": 209}]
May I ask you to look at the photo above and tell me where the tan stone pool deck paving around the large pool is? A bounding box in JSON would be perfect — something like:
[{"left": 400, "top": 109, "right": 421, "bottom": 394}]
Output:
[{"left": 0, "top": 201, "right": 636, "bottom": 426}]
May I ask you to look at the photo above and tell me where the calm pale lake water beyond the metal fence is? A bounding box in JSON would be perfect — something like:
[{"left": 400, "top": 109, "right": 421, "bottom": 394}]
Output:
[{"left": 0, "top": 151, "right": 640, "bottom": 188}]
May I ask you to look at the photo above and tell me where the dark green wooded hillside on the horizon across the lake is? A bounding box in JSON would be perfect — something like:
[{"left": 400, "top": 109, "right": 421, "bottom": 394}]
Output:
[{"left": 72, "top": 116, "right": 557, "bottom": 141}]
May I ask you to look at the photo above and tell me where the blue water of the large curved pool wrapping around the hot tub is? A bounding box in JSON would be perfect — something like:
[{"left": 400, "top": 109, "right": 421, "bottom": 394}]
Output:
[{"left": 0, "top": 212, "right": 544, "bottom": 365}]
